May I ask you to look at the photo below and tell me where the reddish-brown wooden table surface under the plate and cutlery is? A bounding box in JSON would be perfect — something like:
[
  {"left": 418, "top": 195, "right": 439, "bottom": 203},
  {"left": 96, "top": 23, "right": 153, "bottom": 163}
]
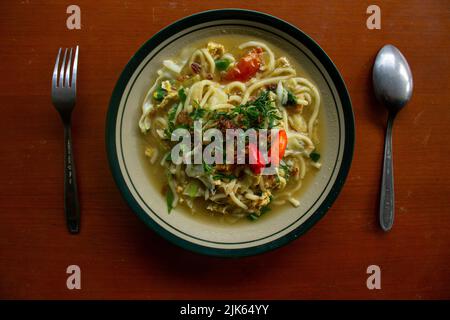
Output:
[{"left": 0, "top": 0, "right": 450, "bottom": 299}]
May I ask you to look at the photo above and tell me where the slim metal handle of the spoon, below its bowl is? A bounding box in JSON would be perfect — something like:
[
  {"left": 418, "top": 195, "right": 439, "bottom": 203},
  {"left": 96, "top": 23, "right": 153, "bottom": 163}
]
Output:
[{"left": 380, "top": 112, "right": 395, "bottom": 231}]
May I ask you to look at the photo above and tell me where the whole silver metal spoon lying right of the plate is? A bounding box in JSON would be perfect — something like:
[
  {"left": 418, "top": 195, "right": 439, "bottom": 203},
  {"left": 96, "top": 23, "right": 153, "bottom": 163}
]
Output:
[{"left": 372, "top": 44, "right": 413, "bottom": 231}]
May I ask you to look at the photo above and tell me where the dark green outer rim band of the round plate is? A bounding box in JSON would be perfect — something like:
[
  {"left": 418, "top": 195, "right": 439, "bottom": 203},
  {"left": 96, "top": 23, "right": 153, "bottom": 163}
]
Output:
[{"left": 106, "top": 9, "right": 355, "bottom": 257}]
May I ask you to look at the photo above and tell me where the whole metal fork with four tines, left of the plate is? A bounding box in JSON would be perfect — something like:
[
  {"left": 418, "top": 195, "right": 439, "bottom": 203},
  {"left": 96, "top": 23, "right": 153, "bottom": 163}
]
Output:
[{"left": 52, "top": 46, "right": 80, "bottom": 234}]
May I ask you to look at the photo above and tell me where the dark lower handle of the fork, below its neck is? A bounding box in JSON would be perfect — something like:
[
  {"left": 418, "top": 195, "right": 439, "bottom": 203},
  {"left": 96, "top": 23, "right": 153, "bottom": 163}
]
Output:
[{"left": 64, "top": 123, "right": 80, "bottom": 234}]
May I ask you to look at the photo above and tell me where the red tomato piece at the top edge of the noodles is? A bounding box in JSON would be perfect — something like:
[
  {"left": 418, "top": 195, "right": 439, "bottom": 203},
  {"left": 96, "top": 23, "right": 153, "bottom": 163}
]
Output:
[{"left": 225, "top": 48, "right": 263, "bottom": 82}]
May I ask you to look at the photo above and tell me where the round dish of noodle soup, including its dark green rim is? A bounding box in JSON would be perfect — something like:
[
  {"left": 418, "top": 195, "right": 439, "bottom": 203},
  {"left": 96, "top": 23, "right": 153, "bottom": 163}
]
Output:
[{"left": 106, "top": 9, "right": 354, "bottom": 257}]
